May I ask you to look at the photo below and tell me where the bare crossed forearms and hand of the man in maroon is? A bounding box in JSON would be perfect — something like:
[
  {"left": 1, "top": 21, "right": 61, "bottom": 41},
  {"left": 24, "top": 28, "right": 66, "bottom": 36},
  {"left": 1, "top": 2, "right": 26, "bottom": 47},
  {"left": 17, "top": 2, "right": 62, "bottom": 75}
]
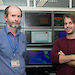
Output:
[{"left": 58, "top": 50, "right": 75, "bottom": 67}]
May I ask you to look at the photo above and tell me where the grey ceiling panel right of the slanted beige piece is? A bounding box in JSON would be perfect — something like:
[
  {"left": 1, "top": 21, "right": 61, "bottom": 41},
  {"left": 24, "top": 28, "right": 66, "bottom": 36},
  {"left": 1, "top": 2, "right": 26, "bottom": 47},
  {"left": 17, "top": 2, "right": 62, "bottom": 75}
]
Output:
[{"left": 37, "top": 0, "right": 69, "bottom": 7}]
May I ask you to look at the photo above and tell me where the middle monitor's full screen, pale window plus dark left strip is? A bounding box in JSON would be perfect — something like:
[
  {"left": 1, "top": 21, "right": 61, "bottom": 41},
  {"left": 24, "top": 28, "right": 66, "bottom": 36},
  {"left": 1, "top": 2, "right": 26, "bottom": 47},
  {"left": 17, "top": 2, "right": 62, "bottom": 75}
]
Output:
[{"left": 25, "top": 31, "right": 52, "bottom": 44}]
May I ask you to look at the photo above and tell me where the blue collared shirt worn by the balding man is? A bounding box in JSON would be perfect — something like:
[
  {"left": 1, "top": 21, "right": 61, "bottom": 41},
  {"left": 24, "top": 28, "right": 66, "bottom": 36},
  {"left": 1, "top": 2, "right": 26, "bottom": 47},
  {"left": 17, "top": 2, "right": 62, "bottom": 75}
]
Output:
[{"left": 0, "top": 27, "right": 26, "bottom": 75}]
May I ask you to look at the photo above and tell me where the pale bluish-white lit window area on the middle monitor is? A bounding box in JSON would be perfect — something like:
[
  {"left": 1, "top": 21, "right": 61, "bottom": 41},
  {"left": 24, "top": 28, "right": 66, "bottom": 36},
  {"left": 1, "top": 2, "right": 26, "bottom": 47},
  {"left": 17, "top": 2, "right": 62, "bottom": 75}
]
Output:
[{"left": 31, "top": 32, "right": 52, "bottom": 43}]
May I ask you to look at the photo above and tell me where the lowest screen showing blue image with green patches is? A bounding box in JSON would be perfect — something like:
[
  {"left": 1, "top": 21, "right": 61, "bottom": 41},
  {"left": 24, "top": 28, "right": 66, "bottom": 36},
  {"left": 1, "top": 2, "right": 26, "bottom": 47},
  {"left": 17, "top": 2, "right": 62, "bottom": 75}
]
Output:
[{"left": 28, "top": 50, "right": 52, "bottom": 65}]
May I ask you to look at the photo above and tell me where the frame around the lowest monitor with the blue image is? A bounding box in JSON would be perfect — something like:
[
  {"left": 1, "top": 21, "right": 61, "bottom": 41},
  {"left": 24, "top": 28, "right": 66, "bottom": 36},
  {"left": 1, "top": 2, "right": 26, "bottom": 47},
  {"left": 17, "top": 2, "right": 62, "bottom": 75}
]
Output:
[{"left": 26, "top": 48, "right": 52, "bottom": 67}]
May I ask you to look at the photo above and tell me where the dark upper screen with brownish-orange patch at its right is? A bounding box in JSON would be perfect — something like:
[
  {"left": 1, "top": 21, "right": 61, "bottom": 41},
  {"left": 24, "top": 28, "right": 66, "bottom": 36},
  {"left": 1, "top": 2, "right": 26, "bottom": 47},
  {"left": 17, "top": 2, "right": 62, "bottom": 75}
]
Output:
[{"left": 25, "top": 12, "right": 51, "bottom": 28}]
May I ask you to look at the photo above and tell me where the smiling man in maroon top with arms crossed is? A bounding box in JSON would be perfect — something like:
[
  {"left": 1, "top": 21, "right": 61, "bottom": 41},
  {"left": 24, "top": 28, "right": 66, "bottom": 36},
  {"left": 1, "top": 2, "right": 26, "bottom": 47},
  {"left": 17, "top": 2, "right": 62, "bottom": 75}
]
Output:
[{"left": 51, "top": 14, "right": 75, "bottom": 75}]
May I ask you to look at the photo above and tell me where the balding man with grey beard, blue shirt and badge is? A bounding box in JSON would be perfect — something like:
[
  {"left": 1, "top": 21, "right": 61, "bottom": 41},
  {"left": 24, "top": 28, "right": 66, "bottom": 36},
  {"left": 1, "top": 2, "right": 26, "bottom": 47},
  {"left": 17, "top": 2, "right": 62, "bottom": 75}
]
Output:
[{"left": 0, "top": 6, "right": 26, "bottom": 75}]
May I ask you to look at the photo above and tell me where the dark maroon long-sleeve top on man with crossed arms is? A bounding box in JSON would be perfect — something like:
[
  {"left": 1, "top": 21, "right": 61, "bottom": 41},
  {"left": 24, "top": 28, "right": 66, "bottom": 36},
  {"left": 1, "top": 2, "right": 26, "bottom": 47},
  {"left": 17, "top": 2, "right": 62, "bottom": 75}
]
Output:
[{"left": 51, "top": 37, "right": 75, "bottom": 75}]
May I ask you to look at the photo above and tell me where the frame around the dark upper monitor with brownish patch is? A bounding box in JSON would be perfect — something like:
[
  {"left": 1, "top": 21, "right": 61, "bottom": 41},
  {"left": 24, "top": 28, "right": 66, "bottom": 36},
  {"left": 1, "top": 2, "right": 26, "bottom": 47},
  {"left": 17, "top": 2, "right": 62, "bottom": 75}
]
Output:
[{"left": 24, "top": 11, "right": 52, "bottom": 29}]
